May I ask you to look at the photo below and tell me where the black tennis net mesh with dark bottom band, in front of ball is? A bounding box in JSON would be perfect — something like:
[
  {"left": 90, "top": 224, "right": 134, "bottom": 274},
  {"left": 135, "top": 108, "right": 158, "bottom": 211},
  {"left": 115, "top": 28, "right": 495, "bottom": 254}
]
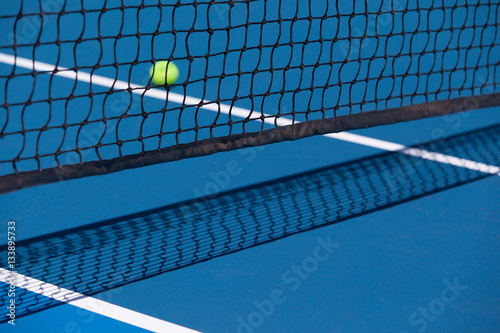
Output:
[{"left": 0, "top": 0, "right": 500, "bottom": 193}]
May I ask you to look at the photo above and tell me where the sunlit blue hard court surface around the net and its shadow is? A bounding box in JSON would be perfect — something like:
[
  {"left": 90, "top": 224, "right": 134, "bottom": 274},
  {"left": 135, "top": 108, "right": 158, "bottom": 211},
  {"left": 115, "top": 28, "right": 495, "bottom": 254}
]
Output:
[{"left": 0, "top": 0, "right": 500, "bottom": 333}]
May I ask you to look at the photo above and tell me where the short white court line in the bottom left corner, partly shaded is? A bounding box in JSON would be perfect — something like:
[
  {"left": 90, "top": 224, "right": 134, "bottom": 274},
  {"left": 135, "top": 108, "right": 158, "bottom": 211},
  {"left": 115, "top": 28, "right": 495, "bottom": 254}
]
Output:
[{"left": 0, "top": 268, "right": 201, "bottom": 333}]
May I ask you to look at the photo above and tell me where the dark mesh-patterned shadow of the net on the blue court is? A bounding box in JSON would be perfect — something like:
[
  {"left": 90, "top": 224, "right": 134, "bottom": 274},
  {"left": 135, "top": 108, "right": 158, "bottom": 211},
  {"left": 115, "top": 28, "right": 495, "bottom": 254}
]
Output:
[{"left": 0, "top": 125, "right": 500, "bottom": 320}]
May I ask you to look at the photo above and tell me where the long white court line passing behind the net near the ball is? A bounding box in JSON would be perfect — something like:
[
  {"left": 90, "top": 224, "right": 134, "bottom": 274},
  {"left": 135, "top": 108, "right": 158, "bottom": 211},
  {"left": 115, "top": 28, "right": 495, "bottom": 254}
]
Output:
[{"left": 0, "top": 53, "right": 499, "bottom": 174}]
